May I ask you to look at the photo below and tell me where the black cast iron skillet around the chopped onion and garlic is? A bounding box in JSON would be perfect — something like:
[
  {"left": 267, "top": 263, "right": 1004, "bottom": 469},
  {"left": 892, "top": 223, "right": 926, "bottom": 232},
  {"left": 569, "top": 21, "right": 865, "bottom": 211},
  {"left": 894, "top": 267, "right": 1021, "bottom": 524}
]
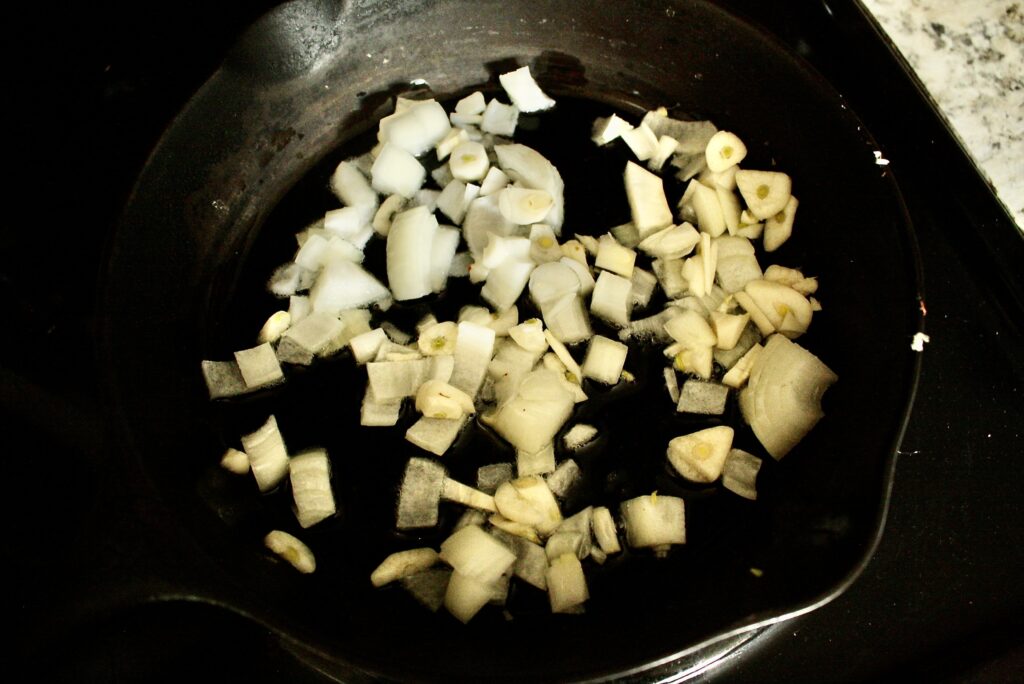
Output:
[{"left": 100, "top": 0, "right": 921, "bottom": 680}]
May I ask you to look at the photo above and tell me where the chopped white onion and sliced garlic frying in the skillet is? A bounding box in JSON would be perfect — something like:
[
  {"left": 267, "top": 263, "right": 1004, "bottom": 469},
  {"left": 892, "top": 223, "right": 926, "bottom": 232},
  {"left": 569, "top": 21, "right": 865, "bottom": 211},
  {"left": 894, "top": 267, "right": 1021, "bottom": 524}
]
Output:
[{"left": 203, "top": 68, "right": 837, "bottom": 622}]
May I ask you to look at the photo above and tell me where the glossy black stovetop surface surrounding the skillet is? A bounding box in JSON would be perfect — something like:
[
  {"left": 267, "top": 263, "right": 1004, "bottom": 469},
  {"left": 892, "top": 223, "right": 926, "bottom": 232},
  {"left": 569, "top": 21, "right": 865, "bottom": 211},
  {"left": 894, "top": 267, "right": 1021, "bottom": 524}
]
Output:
[{"left": 6, "top": 0, "right": 1024, "bottom": 682}]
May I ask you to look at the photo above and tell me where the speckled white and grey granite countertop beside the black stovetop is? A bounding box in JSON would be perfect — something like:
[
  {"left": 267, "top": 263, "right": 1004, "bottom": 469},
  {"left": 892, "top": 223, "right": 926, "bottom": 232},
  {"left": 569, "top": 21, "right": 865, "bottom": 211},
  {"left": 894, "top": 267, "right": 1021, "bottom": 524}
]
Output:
[{"left": 860, "top": 0, "right": 1024, "bottom": 231}]
